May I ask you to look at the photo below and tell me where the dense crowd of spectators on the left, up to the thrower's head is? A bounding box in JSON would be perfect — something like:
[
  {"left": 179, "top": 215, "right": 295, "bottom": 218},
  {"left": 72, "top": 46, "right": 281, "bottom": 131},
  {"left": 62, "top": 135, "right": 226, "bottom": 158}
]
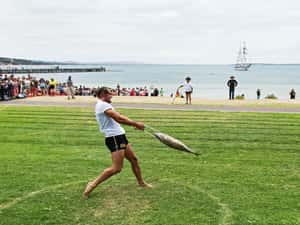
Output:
[{"left": 0, "top": 74, "right": 93, "bottom": 101}]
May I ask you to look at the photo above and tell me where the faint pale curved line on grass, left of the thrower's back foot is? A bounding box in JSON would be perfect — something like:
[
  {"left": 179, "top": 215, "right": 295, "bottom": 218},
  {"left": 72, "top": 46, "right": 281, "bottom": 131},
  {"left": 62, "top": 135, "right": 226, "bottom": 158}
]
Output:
[{"left": 0, "top": 180, "right": 87, "bottom": 211}]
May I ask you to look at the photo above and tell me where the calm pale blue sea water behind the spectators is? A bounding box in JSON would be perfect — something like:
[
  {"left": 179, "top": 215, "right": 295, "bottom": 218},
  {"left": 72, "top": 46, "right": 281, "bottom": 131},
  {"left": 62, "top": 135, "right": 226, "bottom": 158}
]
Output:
[{"left": 18, "top": 64, "right": 300, "bottom": 99}]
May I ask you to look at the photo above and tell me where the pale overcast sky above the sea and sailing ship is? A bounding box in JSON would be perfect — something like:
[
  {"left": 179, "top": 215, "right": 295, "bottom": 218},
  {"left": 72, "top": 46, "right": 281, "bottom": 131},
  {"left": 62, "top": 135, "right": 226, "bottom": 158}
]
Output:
[{"left": 0, "top": 0, "right": 300, "bottom": 64}]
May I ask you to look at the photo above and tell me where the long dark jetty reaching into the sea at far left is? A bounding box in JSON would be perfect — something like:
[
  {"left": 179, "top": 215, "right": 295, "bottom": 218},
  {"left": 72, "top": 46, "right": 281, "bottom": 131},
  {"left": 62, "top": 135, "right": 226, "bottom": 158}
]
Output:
[{"left": 0, "top": 66, "right": 106, "bottom": 74}]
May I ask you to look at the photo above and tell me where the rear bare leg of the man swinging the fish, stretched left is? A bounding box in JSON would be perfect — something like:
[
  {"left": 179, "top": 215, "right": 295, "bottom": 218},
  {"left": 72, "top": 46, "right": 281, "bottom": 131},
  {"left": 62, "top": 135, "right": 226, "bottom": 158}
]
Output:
[{"left": 82, "top": 150, "right": 125, "bottom": 198}]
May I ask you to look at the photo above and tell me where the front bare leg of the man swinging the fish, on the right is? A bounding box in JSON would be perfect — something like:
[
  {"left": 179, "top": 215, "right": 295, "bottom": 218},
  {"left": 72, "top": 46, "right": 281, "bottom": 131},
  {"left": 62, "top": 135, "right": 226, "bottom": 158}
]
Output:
[{"left": 125, "top": 144, "right": 152, "bottom": 188}]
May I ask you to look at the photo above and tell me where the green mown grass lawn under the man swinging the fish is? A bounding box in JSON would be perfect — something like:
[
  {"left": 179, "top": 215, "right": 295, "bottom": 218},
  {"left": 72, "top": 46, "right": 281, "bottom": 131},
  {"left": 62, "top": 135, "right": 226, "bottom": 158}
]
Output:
[{"left": 0, "top": 107, "right": 300, "bottom": 225}]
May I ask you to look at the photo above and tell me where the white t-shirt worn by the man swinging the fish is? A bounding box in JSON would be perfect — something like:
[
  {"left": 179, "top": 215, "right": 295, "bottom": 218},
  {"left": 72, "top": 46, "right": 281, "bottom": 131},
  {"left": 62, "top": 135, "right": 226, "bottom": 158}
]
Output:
[{"left": 95, "top": 100, "right": 125, "bottom": 137}]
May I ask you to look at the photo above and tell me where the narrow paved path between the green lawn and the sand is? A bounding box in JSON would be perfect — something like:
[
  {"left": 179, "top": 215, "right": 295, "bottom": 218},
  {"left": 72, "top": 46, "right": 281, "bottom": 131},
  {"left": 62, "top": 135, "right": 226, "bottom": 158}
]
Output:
[{"left": 0, "top": 100, "right": 300, "bottom": 113}]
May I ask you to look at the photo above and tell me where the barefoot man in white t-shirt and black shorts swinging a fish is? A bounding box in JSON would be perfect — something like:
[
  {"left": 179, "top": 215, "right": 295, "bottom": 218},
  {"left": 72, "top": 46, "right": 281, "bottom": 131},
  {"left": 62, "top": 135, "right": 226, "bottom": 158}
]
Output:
[{"left": 83, "top": 87, "right": 152, "bottom": 198}]
